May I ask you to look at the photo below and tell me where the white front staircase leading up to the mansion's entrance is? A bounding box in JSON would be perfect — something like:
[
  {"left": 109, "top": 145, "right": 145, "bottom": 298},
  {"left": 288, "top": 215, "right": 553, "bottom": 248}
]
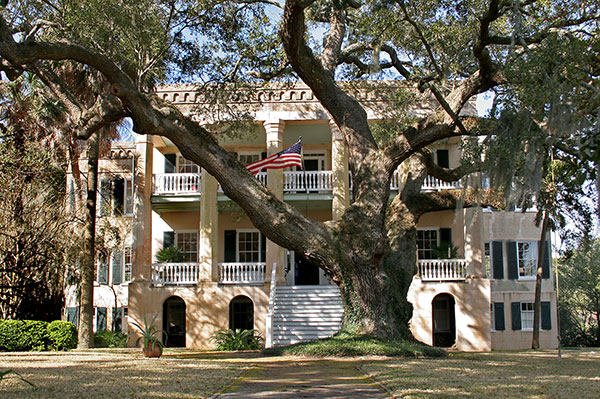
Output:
[{"left": 273, "top": 285, "right": 344, "bottom": 346}]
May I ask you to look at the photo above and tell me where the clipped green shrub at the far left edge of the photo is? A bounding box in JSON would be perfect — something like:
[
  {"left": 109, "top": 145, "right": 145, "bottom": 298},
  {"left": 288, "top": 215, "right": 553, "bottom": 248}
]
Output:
[{"left": 0, "top": 320, "right": 50, "bottom": 351}]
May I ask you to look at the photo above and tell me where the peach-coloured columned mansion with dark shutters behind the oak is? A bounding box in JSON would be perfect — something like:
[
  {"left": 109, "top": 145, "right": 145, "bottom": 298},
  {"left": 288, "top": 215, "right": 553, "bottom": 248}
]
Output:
[{"left": 64, "top": 84, "right": 558, "bottom": 351}]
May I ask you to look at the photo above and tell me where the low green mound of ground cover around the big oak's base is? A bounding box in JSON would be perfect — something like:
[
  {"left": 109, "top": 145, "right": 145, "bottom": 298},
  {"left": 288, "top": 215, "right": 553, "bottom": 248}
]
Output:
[{"left": 264, "top": 333, "right": 446, "bottom": 357}]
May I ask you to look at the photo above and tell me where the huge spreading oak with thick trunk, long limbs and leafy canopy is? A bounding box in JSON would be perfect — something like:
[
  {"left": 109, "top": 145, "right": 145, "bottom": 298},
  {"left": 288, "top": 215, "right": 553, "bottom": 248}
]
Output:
[{"left": 0, "top": 0, "right": 600, "bottom": 336}]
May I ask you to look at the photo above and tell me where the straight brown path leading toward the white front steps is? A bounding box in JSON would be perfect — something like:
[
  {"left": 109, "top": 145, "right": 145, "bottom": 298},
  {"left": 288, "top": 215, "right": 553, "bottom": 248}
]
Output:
[{"left": 213, "top": 358, "right": 391, "bottom": 399}]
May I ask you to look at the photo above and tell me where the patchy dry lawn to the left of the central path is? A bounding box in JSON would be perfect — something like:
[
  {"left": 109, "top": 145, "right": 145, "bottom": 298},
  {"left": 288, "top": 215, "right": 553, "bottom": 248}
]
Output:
[{"left": 0, "top": 349, "right": 247, "bottom": 399}]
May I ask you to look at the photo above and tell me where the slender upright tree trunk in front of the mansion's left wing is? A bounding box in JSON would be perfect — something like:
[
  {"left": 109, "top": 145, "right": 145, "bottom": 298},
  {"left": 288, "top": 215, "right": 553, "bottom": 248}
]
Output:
[{"left": 77, "top": 131, "right": 100, "bottom": 349}]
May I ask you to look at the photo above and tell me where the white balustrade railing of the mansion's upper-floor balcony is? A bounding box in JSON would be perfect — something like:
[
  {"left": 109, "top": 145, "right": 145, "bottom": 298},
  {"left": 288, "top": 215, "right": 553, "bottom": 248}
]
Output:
[{"left": 153, "top": 170, "right": 462, "bottom": 195}]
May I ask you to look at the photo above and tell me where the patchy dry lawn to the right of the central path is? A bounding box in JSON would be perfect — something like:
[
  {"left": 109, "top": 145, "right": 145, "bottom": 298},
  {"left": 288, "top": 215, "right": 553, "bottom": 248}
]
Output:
[{"left": 359, "top": 349, "right": 600, "bottom": 399}]
